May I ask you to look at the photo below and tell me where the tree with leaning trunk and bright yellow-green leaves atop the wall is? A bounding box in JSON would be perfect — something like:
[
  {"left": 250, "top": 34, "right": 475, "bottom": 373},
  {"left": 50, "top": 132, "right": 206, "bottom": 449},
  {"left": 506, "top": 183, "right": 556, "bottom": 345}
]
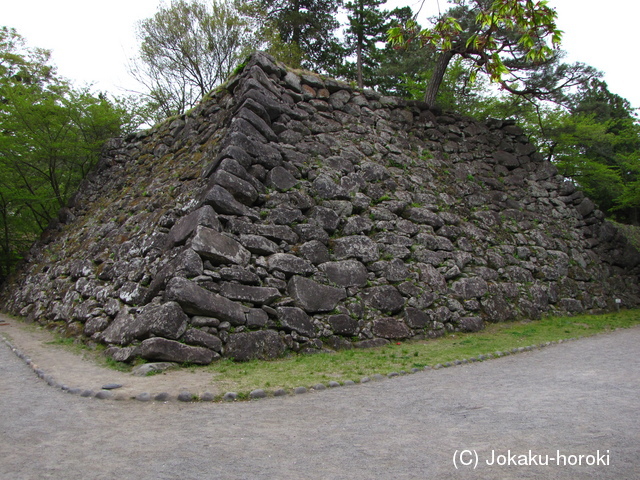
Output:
[{"left": 388, "top": 0, "right": 562, "bottom": 105}]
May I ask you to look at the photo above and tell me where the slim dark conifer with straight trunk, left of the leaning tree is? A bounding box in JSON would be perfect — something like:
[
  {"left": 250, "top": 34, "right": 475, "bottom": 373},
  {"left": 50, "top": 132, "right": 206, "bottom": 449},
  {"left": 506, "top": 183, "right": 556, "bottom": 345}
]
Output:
[{"left": 345, "top": 0, "right": 389, "bottom": 88}]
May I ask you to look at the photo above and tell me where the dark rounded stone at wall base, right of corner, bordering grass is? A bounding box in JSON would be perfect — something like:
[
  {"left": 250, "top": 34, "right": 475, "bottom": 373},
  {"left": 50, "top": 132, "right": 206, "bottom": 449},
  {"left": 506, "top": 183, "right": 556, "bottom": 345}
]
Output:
[{"left": 224, "top": 330, "right": 286, "bottom": 362}]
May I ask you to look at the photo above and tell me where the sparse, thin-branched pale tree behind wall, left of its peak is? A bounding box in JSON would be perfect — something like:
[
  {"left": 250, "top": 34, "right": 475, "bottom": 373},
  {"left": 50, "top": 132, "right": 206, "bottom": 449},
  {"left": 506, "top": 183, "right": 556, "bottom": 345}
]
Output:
[{"left": 131, "top": 0, "right": 256, "bottom": 121}]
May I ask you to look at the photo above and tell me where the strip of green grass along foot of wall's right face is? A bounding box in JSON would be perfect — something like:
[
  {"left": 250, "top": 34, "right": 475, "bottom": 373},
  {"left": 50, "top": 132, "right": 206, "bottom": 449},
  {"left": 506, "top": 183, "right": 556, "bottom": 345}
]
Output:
[{"left": 199, "top": 310, "right": 640, "bottom": 392}]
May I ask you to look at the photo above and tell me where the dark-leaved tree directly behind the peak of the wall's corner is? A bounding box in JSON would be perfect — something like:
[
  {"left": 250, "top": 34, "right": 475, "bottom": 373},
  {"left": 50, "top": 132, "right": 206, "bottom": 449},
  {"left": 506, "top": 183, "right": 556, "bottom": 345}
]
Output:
[{"left": 242, "top": 0, "right": 345, "bottom": 74}]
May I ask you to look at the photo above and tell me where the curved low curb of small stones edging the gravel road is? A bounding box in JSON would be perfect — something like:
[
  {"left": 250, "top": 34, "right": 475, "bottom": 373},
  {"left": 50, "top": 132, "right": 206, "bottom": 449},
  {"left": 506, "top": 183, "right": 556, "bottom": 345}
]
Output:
[{"left": 0, "top": 334, "right": 599, "bottom": 403}]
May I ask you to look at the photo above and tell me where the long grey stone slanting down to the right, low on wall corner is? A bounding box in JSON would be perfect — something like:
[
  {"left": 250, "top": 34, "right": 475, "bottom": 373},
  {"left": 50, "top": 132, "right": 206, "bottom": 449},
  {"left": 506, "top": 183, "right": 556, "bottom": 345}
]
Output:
[{"left": 165, "top": 277, "right": 247, "bottom": 326}]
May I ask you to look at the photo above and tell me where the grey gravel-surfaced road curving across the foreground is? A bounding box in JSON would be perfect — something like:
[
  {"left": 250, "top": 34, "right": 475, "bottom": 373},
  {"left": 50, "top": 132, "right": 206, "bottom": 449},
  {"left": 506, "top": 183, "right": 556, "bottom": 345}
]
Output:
[{"left": 0, "top": 328, "right": 640, "bottom": 480}]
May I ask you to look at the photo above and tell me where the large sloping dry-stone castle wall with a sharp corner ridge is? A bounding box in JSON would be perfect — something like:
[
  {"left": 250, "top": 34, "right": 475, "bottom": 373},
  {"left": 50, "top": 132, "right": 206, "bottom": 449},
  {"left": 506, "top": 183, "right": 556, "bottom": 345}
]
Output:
[{"left": 3, "top": 54, "right": 640, "bottom": 363}]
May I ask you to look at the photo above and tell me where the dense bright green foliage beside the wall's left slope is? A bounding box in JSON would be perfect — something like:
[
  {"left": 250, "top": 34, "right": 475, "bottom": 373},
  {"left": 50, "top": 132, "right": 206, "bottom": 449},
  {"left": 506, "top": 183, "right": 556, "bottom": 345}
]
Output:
[{"left": 0, "top": 27, "right": 130, "bottom": 276}]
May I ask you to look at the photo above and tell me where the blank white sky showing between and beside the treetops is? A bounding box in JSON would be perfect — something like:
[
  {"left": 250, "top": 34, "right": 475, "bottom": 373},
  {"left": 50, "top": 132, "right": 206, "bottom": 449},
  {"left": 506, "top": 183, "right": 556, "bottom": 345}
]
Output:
[{"left": 0, "top": 0, "right": 640, "bottom": 108}]
